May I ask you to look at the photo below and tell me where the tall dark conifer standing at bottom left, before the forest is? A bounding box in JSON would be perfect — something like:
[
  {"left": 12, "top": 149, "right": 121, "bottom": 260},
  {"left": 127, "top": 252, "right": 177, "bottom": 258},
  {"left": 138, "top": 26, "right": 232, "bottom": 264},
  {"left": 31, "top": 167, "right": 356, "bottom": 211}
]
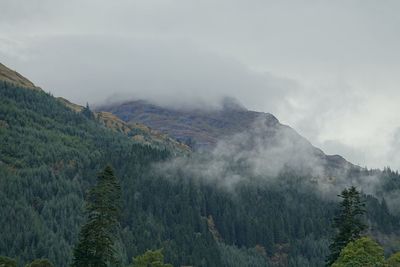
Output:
[{"left": 72, "top": 166, "right": 121, "bottom": 267}]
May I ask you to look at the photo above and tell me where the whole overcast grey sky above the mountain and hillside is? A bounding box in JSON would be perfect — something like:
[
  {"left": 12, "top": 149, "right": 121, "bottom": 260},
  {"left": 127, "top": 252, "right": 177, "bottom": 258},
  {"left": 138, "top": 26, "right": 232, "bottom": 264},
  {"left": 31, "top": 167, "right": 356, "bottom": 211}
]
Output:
[{"left": 0, "top": 0, "right": 400, "bottom": 169}]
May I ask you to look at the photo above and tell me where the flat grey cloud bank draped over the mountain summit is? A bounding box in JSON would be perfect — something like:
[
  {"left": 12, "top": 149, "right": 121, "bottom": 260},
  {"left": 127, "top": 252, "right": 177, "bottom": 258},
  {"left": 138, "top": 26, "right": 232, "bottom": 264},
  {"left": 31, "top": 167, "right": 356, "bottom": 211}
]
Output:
[{"left": 0, "top": 36, "right": 296, "bottom": 113}]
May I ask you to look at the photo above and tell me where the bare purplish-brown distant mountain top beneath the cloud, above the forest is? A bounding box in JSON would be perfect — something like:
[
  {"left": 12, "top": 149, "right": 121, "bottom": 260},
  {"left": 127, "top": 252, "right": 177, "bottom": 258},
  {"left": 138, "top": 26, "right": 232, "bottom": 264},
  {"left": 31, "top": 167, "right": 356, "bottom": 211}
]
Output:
[{"left": 97, "top": 98, "right": 359, "bottom": 175}]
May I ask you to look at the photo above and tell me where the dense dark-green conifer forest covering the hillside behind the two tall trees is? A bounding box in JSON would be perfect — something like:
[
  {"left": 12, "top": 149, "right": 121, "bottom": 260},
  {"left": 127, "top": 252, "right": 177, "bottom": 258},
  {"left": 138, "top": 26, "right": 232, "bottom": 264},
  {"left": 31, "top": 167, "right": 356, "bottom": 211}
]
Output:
[{"left": 0, "top": 82, "right": 400, "bottom": 267}]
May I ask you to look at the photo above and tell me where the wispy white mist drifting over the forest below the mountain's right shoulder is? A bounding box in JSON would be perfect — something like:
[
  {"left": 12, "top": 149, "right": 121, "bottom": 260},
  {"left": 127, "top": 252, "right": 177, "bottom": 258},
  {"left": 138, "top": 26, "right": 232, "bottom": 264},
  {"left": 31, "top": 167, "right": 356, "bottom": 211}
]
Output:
[{"left": 155, "top": 116, "right": 397, "bottom": 211}]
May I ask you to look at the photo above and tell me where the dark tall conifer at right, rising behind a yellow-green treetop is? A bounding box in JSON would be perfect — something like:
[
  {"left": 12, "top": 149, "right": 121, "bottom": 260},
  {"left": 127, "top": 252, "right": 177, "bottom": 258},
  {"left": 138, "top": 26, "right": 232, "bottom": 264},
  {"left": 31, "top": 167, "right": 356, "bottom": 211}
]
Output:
[{"left": 327, "top": 186, "right": 366, "bottom": 266}]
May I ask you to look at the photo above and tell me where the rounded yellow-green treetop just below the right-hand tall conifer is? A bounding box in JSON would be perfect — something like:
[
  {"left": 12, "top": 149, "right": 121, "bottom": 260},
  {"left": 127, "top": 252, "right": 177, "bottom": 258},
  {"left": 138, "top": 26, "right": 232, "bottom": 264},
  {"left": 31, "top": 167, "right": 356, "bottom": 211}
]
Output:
[{"left": 332, "top": 237, "right": 385, "bottom": 267}]
